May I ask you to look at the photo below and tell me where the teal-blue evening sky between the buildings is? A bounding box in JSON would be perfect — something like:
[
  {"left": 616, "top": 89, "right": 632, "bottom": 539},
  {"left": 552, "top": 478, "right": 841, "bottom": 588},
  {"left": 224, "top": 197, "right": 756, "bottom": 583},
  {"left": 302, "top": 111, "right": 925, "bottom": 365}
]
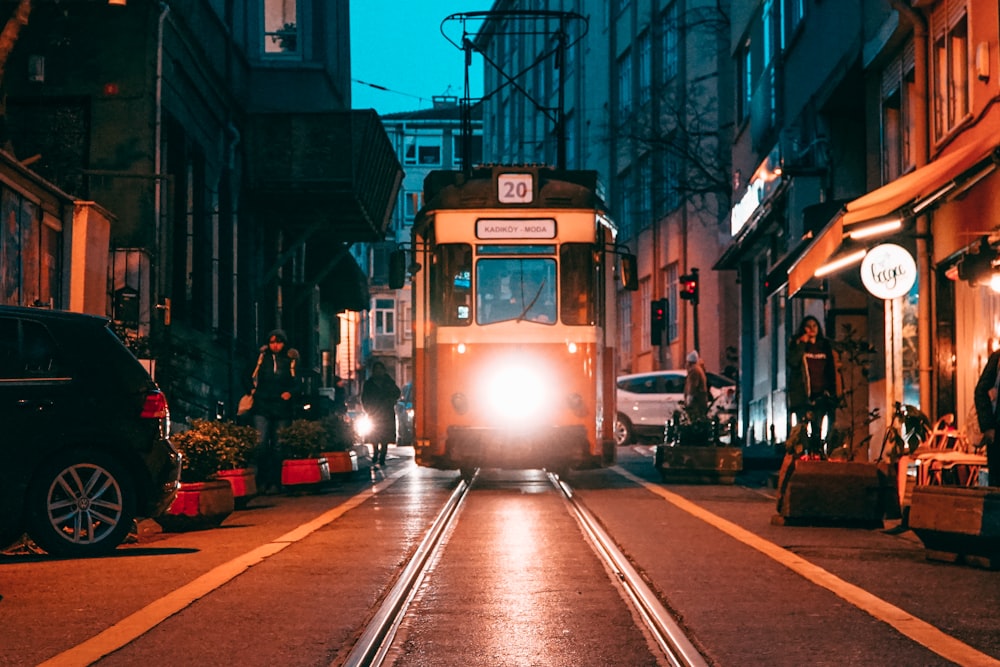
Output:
[{"left": 350, "top": 0, "right": 493, "bottom": 115}]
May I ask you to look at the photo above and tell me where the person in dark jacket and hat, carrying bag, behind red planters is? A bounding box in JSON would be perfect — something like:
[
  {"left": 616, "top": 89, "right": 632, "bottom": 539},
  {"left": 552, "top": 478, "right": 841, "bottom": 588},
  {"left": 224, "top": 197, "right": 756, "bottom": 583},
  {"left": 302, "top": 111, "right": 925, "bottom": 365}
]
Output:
[{"left": 252, "top": 329, "right": 299, "bottom": 495}]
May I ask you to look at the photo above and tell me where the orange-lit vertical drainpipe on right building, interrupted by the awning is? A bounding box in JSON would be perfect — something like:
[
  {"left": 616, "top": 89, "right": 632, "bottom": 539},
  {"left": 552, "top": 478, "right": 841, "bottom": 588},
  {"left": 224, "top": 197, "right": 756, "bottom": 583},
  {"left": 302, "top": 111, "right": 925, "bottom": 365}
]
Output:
[{"left": 890, "top": 0, "right": 936, "bottom": 415}]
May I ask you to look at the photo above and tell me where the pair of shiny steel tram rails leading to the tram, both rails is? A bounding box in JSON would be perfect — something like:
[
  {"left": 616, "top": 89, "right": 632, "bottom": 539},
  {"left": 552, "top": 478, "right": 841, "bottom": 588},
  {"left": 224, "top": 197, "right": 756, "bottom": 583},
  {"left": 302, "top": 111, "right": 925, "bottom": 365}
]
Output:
[{"left": 336, "top": 471, "right": 708, "bottom": 667}]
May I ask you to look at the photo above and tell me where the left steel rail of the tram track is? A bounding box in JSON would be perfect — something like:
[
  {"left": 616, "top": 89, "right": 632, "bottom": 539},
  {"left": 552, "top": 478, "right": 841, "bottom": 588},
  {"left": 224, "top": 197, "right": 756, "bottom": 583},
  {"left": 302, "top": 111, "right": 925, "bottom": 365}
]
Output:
[{"left": 334, "top": 476, "right": 474, "bottom": 667}]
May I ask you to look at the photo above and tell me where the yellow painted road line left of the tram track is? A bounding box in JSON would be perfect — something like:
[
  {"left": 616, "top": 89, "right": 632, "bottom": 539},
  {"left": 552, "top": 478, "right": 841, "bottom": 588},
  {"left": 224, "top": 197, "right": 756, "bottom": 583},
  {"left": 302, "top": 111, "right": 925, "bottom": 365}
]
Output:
[{"left": 40, "top": 466, "right": 413, "bottom": 667}]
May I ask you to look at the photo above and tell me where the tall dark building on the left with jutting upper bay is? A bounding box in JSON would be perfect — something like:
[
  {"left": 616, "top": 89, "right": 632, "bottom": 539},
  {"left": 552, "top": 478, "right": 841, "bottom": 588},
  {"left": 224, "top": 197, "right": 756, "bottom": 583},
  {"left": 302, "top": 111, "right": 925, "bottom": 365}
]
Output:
[{"left": 3, "top": 0, "right": 402, "bottom": 419}]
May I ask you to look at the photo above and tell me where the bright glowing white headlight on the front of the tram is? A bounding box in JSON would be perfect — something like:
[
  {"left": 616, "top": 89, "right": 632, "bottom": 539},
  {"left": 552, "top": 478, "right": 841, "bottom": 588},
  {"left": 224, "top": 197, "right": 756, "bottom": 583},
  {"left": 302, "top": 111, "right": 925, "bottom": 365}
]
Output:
[{"left": 482, "top": 364, "right": 553, "bottom": 427}]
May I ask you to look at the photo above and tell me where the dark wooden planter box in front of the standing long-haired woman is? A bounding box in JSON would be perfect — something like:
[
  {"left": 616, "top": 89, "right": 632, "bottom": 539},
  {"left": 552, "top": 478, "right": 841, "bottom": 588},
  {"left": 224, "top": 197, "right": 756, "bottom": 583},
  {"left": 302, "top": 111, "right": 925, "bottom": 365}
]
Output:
[{"left": 772, "top": 459, "right": 883, "bottom": 527}]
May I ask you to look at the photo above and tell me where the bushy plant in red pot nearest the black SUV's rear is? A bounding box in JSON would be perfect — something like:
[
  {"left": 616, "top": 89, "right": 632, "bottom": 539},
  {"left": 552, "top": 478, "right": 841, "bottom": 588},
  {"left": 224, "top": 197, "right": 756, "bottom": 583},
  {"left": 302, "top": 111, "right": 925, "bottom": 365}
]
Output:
[{"left": 156, "top": 419, "right": 256, "bottom": 531}]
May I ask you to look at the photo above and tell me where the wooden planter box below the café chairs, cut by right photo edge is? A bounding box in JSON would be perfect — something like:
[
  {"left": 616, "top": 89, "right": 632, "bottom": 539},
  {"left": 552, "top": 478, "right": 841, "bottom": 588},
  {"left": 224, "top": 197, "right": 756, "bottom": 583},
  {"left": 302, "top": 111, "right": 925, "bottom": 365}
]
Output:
[{"left": 909, "top": 486, "right": 1000, "bottom": 570}]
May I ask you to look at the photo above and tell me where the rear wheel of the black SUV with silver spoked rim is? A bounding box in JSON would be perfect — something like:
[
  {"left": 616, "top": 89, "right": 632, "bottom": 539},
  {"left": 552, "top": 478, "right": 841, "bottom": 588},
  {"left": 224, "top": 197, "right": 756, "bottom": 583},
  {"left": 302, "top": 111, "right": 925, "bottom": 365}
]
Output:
[{"left": 27, "top": 450, "right": 135, "bottom": 557}]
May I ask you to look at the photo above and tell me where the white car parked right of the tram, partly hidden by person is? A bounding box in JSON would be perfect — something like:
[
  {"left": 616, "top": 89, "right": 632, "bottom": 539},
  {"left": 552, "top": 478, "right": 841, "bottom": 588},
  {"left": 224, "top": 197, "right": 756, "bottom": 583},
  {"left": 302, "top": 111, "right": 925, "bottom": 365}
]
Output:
[{"left": 615, "top": 369, "right": 737, "bottom": 446}]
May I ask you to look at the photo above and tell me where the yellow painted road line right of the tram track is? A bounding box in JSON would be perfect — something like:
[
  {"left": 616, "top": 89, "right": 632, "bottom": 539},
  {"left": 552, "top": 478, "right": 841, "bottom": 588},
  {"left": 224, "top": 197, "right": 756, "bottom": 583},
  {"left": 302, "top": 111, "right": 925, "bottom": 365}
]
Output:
[{"left": 612, "top": 466, "right": 1000, "bottom": 667}]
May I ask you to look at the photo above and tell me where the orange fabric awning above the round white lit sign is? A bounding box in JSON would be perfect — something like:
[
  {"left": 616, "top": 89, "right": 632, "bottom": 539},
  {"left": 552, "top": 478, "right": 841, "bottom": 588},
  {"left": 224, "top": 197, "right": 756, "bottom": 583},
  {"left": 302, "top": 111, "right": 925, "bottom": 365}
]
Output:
[{"left": 788, "top": 136, "right": 998, "bottom": 296}]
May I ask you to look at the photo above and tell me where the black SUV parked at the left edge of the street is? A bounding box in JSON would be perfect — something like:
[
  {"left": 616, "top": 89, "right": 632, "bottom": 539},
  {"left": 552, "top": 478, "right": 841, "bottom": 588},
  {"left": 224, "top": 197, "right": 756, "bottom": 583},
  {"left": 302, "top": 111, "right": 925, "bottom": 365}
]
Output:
[{"left": 0, "top": 306, "right": 180, "bottom": 556}]
